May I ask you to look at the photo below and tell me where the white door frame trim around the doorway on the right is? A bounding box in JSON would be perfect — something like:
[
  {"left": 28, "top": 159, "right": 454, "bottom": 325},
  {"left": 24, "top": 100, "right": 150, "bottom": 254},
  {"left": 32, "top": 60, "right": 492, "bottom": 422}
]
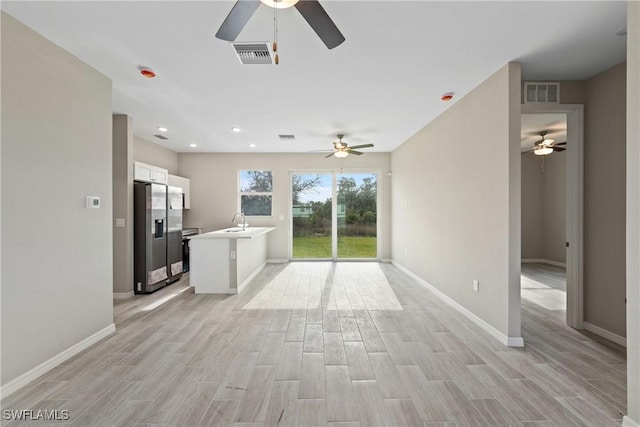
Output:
[{"left": 521, "top": 104, "right": 584, "bottom": 329}]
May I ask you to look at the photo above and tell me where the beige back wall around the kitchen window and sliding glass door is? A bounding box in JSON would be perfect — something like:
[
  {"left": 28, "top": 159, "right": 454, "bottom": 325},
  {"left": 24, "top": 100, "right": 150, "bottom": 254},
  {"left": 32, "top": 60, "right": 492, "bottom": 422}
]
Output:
[{"left": 178, "top": 153, "right": 391, "bottom": 260}]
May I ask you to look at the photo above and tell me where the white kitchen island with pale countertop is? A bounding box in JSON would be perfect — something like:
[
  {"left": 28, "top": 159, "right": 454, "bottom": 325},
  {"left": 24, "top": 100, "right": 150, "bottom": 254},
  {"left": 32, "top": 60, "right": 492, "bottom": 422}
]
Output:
[{"left": 189, "top": 227, "right": 275, "bottom": 294}]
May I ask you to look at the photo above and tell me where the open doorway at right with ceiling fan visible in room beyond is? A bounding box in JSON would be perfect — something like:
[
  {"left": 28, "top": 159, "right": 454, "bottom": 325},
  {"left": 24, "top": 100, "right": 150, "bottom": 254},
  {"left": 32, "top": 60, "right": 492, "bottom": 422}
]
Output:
[{"left": 521, "top": 104, "right": 584, "bottom": 329}]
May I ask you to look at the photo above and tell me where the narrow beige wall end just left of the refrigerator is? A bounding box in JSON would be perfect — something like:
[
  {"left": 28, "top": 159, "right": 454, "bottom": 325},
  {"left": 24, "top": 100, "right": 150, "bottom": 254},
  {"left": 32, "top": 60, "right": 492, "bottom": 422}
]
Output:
[{"left": 112, "top": 114, "right": 133, "bottom": 298}]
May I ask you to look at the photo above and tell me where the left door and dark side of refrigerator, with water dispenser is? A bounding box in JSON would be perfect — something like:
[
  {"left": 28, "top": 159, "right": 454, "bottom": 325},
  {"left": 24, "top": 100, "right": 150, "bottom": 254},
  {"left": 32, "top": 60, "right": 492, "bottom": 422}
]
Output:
[{"left": 133, "top": 182, "right": 169, "bottom": 294}]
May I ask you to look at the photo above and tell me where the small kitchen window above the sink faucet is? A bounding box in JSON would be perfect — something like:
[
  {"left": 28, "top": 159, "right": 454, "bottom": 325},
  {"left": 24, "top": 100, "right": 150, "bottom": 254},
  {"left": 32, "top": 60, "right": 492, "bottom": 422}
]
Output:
[{"left": 240, "top": 170, "right": 273, "bottom": 216}]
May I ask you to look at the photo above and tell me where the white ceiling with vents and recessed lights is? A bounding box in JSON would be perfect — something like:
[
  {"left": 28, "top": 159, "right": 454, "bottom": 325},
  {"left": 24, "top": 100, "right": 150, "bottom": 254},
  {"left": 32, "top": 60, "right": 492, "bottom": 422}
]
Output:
[{"left": 1, "top": 0, "right": 626, "bottom": 152}]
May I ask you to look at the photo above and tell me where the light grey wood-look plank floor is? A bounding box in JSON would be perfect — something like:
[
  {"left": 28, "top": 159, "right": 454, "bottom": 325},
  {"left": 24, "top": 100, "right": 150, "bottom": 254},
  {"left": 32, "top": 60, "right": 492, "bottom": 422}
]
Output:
[{"left": 2, "top": 262, "right": 626, "bottom": 427}]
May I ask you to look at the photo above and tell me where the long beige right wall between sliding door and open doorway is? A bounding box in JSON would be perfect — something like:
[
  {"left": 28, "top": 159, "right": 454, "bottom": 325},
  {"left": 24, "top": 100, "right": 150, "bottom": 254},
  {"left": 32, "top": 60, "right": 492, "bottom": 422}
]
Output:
[{"left": 391, "top": 64, "right": 521, "bottom": 337}]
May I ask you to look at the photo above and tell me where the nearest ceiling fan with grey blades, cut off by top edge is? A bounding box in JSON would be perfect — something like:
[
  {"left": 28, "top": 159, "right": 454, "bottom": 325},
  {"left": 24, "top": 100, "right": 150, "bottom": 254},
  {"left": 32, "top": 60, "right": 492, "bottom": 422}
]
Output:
[{"left": 216, "top": 0, "right": 345, "bottom": 49}]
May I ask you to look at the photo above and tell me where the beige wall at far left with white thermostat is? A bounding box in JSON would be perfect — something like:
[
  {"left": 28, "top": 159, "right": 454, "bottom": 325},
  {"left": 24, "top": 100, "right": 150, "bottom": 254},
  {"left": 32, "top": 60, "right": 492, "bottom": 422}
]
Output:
[{"left": 1, "top": 13, "right": 113, "bottom": 386}]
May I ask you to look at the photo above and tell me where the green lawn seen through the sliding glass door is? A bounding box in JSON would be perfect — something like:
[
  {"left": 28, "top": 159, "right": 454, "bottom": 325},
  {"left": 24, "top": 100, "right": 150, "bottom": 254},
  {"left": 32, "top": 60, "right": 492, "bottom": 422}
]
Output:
[{"left": 293, "top": 236, "right": 377, "bottom": 258}]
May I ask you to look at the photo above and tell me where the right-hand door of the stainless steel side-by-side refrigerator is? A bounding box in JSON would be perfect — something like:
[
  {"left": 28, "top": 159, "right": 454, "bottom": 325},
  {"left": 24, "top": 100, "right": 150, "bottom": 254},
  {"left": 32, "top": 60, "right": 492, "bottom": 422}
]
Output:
[{"left": 167, "top": 186, "right": 183, "bottom": 283}]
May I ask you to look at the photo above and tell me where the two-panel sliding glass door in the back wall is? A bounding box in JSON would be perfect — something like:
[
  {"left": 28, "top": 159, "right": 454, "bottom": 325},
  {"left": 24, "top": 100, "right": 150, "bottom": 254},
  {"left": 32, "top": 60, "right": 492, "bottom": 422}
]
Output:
[{"left": 291, "top": 172, "right": 378, "bottom": 260}]
